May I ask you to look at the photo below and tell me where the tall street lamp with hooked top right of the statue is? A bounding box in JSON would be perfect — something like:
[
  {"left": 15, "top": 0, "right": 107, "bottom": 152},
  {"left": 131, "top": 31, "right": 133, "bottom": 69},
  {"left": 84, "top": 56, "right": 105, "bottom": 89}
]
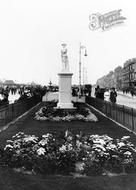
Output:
[{"left": 79, "top": 43, "right": 87, "bottom": 98}]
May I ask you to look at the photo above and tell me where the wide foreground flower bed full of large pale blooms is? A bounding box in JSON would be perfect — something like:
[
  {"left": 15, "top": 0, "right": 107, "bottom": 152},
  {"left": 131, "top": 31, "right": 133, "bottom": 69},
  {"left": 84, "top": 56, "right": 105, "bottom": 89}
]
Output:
[{"left": 0, "top": 131, "right": 136, "bottom": 175}]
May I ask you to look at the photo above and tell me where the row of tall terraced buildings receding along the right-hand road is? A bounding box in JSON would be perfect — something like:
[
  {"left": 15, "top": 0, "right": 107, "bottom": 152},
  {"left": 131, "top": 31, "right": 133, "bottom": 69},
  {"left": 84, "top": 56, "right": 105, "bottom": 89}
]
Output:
[{"left": 97, "top": 58, "right": 136, "bottom": 92}]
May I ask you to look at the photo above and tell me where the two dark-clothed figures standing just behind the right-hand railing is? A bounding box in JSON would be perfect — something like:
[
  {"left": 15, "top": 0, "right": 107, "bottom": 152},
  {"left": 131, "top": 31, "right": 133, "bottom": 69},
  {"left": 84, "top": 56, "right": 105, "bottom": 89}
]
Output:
[{"left": 95, "top": 85, "right": 117, "bottom": 103}]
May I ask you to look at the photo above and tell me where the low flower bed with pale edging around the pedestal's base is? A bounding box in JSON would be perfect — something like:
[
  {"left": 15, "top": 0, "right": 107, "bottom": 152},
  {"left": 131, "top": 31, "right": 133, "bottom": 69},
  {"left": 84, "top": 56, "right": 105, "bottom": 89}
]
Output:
[{"left": 35, "top": 104, "right": 98, "bottom": 121}]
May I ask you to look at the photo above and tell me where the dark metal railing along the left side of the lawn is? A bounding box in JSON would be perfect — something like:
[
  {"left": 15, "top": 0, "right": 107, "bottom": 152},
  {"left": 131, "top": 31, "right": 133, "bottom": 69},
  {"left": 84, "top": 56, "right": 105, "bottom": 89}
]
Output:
[{"left": 0, "top": 96, "right": 41, "bottom": 127}]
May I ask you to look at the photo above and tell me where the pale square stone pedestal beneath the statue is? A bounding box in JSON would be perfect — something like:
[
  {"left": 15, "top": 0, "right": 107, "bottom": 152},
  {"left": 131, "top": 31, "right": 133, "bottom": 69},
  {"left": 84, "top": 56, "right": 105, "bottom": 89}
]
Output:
[{"left": 57, "top": 72, "right": 74, "bottom": 109}]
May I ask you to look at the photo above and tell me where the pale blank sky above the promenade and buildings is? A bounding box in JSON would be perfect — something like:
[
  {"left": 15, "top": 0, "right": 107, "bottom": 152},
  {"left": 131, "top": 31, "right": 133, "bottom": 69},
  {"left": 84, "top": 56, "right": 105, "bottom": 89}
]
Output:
[{"left": 0, "top": 0, "right": 136, "bottom": 85}]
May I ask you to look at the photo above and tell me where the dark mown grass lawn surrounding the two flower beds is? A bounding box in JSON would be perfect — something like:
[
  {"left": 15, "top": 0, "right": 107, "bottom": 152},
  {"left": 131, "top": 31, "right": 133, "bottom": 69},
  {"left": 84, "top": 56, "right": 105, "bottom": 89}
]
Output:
[{"left": 0, "top": 104, "right": 136, "bottom": 190}]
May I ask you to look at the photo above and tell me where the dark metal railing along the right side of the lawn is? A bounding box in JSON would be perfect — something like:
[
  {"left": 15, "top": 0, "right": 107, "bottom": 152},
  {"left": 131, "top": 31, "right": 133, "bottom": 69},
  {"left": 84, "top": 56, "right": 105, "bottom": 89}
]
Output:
[{"left": 86, "top": 97, "right": 136, "bottom": 132}]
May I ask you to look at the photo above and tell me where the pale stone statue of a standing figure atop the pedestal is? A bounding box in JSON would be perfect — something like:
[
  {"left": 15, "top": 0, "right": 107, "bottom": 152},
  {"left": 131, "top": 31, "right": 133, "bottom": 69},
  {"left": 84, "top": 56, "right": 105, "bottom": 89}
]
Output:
[{"left": 61, "top": 44, "right": 69, "bottom": 71}]
